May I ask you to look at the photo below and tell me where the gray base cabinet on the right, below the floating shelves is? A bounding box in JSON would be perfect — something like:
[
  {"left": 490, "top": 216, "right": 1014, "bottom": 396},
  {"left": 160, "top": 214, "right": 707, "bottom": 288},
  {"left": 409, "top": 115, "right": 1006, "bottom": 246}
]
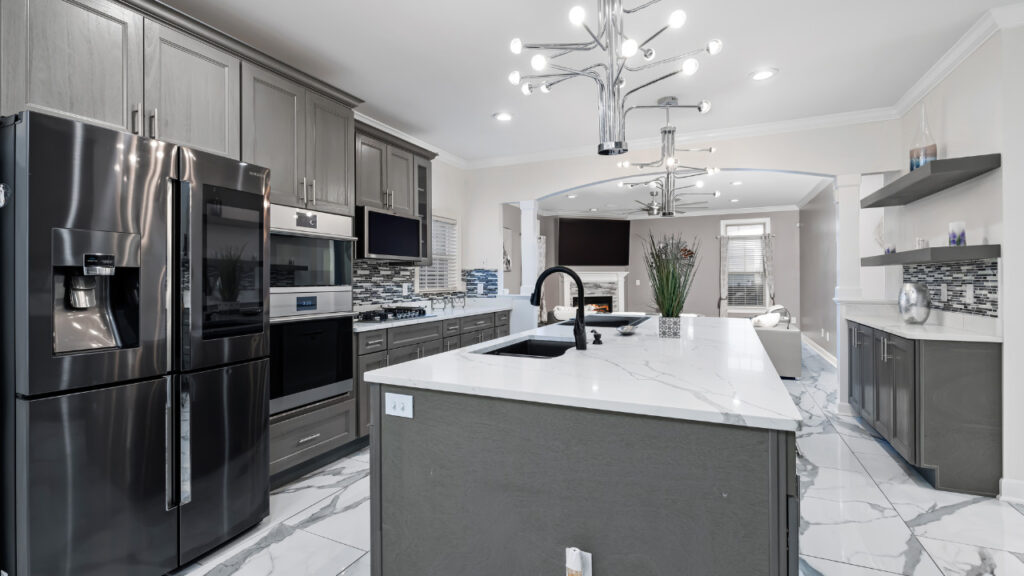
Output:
[{"left": 847, "top": 322, "right": 1002, "bottom": 495}]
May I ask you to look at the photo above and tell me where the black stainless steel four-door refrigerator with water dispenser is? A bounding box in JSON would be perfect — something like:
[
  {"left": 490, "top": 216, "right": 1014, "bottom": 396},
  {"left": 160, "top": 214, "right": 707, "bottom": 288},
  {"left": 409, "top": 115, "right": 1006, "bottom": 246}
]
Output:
[{"left": 0, "top": 112, "right": 269, "bottom": 576}]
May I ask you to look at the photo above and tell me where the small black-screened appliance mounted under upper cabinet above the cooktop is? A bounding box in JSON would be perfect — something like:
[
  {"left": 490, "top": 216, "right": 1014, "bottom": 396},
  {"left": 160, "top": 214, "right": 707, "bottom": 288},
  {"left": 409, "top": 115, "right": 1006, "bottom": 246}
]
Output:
[{"left": 355, "top": 206, "right": 423, "bottom": 261}]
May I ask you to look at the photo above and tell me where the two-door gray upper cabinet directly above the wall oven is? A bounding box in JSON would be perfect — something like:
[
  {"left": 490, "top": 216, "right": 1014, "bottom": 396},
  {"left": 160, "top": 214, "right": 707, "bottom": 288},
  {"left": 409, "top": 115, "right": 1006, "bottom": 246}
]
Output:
[{"left": 242, "top": 63, "right": 354, "bottom": 215}]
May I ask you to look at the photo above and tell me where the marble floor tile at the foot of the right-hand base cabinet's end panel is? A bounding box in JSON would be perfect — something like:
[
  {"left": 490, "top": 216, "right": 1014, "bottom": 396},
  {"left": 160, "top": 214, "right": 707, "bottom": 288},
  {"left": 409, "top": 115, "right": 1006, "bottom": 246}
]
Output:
[{"left": 859, "top": 454, "right": 1024, "bottom": 553}]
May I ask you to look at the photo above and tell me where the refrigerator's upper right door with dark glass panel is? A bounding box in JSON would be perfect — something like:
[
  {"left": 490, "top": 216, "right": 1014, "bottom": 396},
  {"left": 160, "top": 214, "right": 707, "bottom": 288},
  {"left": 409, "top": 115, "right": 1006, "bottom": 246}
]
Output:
[{"left": 177, "top": 149, "right": 270, "bottom": 371}]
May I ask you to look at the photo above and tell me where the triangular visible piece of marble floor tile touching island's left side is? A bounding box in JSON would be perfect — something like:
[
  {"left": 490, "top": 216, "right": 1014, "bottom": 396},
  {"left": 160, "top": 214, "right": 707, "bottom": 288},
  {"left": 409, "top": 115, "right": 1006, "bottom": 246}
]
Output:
[{"left": 286, "top": 471, "right": 370, "bottom": 551}]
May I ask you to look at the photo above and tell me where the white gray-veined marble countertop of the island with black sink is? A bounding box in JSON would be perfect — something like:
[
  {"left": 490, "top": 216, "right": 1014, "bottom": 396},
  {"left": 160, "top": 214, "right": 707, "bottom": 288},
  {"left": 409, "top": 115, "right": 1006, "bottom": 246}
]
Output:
[{"left": 366, "top": 318, "right": 801, "bottom": 430}]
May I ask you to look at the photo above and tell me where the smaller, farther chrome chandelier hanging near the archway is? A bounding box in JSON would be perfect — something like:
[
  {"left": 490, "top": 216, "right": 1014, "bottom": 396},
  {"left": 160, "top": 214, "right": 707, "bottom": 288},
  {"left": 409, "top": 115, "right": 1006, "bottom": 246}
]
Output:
[{"left": 618, "top": 96, "right": 722, "bottom": 216}]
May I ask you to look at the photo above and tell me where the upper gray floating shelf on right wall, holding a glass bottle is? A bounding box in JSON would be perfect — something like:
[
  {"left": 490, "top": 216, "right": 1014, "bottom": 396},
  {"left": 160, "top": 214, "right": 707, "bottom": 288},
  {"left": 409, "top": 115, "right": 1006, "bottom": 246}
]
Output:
[{"left": 860, "top": 154, "right": 1002, "bottom": 208}]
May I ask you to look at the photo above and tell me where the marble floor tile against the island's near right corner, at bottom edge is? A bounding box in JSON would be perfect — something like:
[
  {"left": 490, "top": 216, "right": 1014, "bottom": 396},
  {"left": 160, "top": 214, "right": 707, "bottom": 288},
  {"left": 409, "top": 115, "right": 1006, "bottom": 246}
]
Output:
[{"left": 800, "top": 468, "right": 940, "bottom": 576}]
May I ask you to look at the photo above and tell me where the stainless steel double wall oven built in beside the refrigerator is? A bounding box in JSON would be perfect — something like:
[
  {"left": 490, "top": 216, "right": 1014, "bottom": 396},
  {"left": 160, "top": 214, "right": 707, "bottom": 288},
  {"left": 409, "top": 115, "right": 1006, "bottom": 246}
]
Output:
[{"left": 270, "top": 204, "right": 355, "bottom": 414}]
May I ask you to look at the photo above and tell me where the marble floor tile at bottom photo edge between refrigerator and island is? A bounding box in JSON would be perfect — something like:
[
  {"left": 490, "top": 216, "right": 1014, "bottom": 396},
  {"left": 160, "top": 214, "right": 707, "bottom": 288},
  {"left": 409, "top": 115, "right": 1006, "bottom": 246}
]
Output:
[{"left": 188, "top": 524, "right": 364, "bottom": 576}]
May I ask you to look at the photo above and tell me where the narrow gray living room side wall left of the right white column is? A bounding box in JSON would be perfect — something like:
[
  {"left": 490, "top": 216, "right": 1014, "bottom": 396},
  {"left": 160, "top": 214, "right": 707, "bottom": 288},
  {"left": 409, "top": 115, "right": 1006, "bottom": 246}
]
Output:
[{"left": 800, "top": 187, "right": 836, "bottom": 356}]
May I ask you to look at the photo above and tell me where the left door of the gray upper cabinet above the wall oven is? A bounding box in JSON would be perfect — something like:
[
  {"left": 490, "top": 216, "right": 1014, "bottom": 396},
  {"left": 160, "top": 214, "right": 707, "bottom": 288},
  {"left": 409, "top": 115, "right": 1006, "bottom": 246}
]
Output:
[{"left": 242, "top": 63, "right": 308, "bottom": 208}]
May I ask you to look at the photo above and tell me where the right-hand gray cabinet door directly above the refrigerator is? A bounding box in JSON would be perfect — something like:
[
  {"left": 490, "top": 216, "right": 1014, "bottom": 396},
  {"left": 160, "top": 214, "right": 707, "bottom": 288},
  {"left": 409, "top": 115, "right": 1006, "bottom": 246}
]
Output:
[{"left": 144, "top": 19, "right": 242, "bottom": 158}]
